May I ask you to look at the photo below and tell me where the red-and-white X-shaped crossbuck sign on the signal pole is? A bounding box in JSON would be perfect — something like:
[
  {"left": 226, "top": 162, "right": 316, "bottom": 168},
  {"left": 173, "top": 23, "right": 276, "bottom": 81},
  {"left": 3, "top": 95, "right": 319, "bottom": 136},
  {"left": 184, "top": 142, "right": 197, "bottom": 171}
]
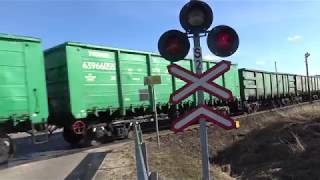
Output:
[{"left": 168, "top": 61, "right": 233, "bottom": 104}]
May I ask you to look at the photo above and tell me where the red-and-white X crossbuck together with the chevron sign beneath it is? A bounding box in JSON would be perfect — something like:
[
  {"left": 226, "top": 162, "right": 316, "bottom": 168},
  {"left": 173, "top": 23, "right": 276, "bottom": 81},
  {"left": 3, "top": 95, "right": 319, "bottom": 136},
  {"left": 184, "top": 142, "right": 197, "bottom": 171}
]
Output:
[{"left": 168, "top": 61, "right": 235, "bottom": 132}]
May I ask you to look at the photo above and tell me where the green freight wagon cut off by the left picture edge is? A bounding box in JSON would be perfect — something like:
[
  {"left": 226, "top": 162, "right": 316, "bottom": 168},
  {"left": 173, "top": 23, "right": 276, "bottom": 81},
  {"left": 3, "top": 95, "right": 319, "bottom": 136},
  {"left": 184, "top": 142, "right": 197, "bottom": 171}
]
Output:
[{"left": 0, "top": 34, "right": 48, "bottom": 163}]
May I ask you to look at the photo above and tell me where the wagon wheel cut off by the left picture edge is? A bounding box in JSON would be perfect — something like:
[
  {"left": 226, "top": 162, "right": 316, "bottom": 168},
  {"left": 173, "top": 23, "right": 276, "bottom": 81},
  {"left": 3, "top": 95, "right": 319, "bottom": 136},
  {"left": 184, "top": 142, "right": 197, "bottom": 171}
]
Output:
[{"left": 0, "top": 135, "right": 15, "bottom": 164}]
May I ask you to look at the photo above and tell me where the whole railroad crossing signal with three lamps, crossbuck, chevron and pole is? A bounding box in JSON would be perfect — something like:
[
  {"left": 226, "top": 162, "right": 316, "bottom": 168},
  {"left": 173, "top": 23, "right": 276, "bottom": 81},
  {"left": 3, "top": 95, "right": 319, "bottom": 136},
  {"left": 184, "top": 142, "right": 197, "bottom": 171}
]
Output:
[{"left": 158, "top": 0, "right": 239, "bottom": 180}]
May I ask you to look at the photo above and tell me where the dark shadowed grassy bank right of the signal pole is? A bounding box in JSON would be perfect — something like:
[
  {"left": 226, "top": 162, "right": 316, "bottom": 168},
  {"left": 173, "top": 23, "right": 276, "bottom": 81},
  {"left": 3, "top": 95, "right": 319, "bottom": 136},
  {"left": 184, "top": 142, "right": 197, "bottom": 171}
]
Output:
[{"left": 214, "top": 119, "right": 320, "bottom": 180}]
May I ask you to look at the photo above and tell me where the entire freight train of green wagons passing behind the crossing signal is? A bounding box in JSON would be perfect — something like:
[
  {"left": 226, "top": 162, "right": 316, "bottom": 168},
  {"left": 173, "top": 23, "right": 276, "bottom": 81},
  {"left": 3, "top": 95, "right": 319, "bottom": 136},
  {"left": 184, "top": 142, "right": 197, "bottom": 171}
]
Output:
[{"left": 0, "top": 34, "right": 320, "bottom": 163}]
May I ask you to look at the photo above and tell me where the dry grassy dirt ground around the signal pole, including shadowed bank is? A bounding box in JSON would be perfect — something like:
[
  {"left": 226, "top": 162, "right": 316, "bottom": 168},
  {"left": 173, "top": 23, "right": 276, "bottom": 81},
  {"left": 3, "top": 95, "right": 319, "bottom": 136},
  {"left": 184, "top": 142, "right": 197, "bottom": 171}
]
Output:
[{"left": 100, "top": 103, "right": 320, "bottom": 180}]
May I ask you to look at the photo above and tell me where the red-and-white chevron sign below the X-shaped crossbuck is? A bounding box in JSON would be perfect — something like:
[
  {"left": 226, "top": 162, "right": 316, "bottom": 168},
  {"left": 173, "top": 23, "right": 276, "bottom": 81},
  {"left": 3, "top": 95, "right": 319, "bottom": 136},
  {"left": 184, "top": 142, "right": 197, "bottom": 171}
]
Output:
[{"left": 171, "top": 104, "right": 236, "bottom": 132}]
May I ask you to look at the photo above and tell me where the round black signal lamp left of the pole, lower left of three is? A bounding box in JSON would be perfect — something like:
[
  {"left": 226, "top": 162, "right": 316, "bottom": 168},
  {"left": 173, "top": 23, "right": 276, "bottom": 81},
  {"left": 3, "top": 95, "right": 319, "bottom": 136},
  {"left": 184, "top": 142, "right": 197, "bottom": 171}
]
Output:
[{"left": 158, "top": 30, "right": 190, "bottom": 62}]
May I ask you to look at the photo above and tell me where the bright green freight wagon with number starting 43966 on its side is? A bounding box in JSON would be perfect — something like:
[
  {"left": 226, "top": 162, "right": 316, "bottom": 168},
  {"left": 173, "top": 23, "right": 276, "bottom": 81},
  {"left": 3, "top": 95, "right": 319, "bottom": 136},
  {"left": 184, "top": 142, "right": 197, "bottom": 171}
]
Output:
[{"left": 45, "top": 42, "right": 239, "bottom": 144}]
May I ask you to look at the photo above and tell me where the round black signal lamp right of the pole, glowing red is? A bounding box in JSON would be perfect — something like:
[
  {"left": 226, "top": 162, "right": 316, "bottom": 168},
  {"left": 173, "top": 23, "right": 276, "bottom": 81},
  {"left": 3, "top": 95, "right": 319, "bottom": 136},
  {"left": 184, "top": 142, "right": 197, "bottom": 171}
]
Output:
[{"left": 207, "top": 25, "right": 239, "bottom": 57}]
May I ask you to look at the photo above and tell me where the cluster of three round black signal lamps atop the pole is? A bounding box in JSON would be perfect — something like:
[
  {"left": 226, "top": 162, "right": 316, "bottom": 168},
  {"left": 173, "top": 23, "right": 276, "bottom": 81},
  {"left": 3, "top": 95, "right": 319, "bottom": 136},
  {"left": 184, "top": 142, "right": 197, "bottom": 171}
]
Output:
[{"left": 158, "top": 0, "right": 239, "bottom": 62}]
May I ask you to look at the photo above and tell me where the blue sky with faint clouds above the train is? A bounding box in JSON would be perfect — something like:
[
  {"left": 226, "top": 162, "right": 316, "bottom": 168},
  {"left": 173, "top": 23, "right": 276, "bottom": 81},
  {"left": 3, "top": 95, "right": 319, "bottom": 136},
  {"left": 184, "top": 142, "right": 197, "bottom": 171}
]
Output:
[{"left": 0, "top": 0, "right": 320, "bottom": 74}]
